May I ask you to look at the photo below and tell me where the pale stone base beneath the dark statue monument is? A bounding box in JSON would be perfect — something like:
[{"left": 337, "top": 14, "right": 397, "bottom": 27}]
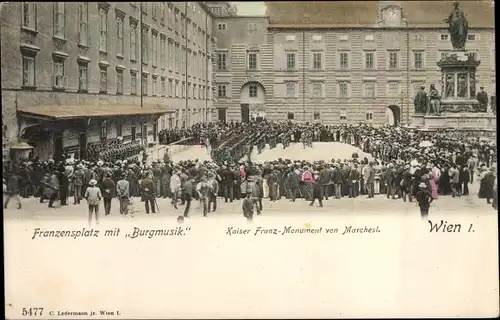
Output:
[{"left": 411, "top": 112, "right": 496, "bottom": 137}]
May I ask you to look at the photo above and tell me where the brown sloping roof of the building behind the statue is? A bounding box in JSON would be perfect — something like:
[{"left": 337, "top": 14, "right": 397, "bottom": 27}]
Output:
[{"left": 266, "top": 0, "right": 495, "bottom": 28}]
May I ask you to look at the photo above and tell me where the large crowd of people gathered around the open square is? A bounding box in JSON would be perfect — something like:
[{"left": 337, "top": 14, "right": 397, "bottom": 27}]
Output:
[{"left": 4, "top": 120, "right": 497, "bottom": 219}]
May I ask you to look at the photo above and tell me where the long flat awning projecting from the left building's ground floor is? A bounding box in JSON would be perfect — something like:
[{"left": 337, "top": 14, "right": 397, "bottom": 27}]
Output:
[{"left": 17, "top": 104, "right": 175, "bottom": 120}]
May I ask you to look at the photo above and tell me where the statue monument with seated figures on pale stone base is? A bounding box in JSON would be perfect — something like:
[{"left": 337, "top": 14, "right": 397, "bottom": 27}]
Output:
[{"left": 411, "top": 2, "right": 496, "bottom": 135}]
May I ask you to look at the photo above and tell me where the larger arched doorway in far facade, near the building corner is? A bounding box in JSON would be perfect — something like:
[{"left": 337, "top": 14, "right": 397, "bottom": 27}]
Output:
[{"left": 240, "top": 81, "right": 266, "bottom": 122}]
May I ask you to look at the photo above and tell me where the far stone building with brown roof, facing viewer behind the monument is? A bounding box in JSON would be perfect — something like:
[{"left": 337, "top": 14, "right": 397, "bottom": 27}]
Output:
[{"left": 214, "top": 0, "right": 495, "bottom": 124}]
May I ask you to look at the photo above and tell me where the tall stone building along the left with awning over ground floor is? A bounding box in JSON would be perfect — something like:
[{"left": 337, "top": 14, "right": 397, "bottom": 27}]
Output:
[{"left": 0, "top": 2, "right": 216, "bottom": 158}]
